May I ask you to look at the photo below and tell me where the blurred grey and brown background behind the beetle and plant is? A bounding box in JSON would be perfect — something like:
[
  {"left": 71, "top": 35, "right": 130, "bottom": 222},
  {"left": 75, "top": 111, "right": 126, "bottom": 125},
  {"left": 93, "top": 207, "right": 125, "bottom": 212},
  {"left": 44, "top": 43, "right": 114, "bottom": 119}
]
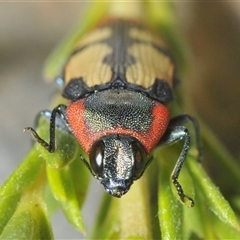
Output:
[{"left": 0, "top": 1, "right": 240, "bottom": 238}]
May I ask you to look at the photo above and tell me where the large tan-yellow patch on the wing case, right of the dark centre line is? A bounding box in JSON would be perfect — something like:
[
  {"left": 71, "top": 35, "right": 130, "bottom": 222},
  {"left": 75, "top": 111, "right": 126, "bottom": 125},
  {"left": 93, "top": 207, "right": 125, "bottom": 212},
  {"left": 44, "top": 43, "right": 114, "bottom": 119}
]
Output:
[{"left": 126, "top": 43, "right": 175, "bottom": 88}]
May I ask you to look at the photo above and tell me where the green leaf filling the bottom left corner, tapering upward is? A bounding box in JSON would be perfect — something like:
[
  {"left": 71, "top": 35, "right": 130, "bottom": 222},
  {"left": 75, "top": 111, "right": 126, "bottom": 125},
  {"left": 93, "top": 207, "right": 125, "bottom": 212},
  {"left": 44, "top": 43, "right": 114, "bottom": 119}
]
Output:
[{"left": 0, "top": 171, "right": 53, "bottom": 239}]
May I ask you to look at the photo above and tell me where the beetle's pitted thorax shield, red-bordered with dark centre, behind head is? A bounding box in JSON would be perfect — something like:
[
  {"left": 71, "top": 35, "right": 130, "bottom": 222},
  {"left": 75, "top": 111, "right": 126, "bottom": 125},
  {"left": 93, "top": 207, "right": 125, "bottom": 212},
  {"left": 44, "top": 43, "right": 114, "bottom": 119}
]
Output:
[{"left": 66, "top": 89, "right": 169, "bottom": 154}]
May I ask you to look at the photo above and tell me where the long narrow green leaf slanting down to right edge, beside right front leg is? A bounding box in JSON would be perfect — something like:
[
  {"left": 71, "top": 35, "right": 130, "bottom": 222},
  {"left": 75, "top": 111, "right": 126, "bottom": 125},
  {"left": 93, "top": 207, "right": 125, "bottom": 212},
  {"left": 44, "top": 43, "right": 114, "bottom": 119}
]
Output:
[{"left": 187, "top": 156, "right": 239, "bottom": 229}]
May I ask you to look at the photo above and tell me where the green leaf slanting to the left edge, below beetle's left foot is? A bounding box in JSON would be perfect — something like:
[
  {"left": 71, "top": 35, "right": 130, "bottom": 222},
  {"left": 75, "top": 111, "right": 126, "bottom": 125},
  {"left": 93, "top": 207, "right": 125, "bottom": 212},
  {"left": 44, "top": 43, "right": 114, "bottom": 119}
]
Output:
[{"left": 0, "top": 148, "right": 45, "bottom": 198}]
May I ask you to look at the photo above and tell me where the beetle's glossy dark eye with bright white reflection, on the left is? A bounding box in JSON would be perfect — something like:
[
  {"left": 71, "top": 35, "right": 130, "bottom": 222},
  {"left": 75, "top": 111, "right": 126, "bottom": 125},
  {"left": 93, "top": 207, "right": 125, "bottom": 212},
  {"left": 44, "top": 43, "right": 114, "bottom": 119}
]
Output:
[{"left": 90, "top": 140, "right": 105, "bottom": 176}]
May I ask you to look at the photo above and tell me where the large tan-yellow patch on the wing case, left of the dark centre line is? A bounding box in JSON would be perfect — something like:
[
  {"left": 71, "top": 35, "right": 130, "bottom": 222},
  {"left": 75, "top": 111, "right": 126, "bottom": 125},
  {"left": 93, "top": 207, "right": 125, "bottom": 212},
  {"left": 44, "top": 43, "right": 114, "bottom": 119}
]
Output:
[{"left": 65, "top": 43, "right": 112, "bottom": 87}]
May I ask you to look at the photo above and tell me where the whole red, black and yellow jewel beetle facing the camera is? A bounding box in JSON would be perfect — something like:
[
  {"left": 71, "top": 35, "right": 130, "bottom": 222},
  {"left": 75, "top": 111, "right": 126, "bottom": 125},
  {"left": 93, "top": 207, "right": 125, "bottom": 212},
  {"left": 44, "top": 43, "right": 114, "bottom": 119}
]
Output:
[{"left": 25, "top": 19, "right": 201, "bottom": 205}]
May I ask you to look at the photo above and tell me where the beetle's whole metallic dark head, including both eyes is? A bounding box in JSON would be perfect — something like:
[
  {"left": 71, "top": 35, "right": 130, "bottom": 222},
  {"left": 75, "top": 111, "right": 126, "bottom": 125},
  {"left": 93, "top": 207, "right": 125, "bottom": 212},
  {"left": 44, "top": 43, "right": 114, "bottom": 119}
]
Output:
[{"left": 90, "top": 134, "right": 146, "bottom": 197}]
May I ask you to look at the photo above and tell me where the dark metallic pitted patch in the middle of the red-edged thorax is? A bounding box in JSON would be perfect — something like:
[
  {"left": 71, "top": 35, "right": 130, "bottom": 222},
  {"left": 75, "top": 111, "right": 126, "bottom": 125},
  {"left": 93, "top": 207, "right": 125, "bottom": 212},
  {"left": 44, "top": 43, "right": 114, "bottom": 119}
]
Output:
[{"left": 84, "top": 89, "right": 153, "bottom": 133}]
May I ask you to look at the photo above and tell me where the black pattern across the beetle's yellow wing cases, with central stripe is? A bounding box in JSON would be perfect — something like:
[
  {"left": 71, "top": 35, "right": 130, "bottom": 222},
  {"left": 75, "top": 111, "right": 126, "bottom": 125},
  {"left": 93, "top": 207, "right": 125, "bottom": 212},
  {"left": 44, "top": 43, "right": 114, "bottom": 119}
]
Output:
[{"left": 63, "top": 20, "right": 175, "bottom": 103}]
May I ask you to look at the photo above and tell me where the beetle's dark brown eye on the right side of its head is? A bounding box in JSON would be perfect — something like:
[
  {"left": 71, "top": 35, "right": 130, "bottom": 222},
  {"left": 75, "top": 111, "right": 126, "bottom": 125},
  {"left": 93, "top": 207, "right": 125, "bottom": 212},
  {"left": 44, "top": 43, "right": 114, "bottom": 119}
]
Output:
[{"left": 132, "top": 141, "right": 146, "bottom": 178}]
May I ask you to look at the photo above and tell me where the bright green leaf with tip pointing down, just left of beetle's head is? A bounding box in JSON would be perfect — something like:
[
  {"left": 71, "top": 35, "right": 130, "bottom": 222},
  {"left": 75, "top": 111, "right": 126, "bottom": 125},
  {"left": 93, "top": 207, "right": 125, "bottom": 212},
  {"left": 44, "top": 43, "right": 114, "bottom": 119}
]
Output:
[{"left": 47, "top": 159, "right": 89, "bottom": 232}]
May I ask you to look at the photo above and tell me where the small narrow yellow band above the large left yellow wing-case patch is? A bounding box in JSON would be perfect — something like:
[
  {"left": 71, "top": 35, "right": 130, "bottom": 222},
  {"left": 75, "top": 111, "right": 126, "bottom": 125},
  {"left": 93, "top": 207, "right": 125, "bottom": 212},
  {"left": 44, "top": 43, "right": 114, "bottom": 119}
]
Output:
[{"left": 75, "top": 27, "right": 112, "bottom": 49}]
